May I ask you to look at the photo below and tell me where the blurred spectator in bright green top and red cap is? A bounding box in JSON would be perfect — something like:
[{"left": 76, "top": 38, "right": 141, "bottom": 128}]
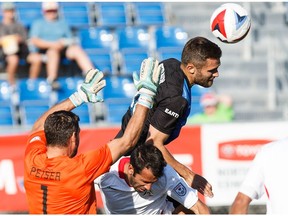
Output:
[{"left": 187, "top": 92, "right": 234, "bottom": 124}]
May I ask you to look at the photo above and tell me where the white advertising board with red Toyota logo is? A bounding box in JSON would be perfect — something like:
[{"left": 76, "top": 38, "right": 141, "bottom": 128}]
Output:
[{"left": 201, "top": 122, "right": 288, "bottom": 206}]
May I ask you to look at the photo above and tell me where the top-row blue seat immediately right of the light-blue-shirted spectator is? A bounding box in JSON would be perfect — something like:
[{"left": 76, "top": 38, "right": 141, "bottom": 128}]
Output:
[{"left": 60, "top": 2, "right": 93, "bottom": 29}]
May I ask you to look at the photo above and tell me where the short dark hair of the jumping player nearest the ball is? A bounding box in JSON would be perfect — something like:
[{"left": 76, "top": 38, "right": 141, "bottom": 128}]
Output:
[{"left": 181, "top": 37, "right": 222, "bottom": 68}]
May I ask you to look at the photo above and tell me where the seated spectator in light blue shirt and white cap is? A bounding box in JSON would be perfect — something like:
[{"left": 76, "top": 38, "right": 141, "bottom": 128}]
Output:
[{"left": 29, "top": 2, "right": 93, "bottom": 88}]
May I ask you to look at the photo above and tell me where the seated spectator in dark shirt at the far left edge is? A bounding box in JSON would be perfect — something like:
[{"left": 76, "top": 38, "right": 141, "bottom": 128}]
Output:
[{"left": 0, "top": 2, "right": 40, "bottom": 92}]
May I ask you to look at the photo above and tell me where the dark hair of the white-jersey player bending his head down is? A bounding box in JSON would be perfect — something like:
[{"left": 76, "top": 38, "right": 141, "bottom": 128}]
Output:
[{"left": 130, "top": 144, "right": 166, "bottom": 178}]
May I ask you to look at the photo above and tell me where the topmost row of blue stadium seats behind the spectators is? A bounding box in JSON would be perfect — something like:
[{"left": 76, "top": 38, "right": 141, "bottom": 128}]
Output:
[{"left": 0, "top": 2, "right": 166, "bottom": 29}]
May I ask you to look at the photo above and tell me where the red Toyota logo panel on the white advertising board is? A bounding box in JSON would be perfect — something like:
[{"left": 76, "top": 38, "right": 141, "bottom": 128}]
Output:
[{"left": 218, "top": 139, "right": 271, "bottom": 161}]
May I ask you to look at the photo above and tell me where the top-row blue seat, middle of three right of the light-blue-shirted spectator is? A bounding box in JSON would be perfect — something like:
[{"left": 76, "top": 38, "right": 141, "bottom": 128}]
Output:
[{"left": 95, "top": 2, "right": 131, "bottom": 28}]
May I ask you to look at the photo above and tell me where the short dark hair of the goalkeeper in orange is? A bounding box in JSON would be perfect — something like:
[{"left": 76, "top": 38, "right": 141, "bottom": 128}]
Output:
[{"left": 44, "top": 110, "right": 80, "bottom": 147}]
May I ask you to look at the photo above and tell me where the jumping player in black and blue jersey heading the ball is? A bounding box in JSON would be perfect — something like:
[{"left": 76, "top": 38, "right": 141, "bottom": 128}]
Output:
[{"left": 116, "top": 37, "right": 222, "bottom": 197}]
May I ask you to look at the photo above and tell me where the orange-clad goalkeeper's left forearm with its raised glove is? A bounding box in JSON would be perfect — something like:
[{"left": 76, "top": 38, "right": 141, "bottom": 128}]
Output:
[{"left": 31, "top": 69, "right": 106, "bottom": 133}]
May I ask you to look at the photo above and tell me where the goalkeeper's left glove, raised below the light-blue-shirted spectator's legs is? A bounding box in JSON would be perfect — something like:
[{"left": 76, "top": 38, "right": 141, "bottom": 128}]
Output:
[{"left": 69, "top": 69, "right": 106, "bottom": 107}]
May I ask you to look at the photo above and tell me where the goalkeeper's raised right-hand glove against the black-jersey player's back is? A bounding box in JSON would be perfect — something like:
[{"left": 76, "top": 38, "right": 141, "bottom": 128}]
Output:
[{"left": 133, "top": 57, "right": 163, "bottom": 109}]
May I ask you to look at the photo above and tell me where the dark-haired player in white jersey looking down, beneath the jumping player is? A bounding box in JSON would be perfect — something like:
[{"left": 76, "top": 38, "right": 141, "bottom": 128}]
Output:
[{"left": 95, "top": 145, "right": 210, "bottom": 214}]
